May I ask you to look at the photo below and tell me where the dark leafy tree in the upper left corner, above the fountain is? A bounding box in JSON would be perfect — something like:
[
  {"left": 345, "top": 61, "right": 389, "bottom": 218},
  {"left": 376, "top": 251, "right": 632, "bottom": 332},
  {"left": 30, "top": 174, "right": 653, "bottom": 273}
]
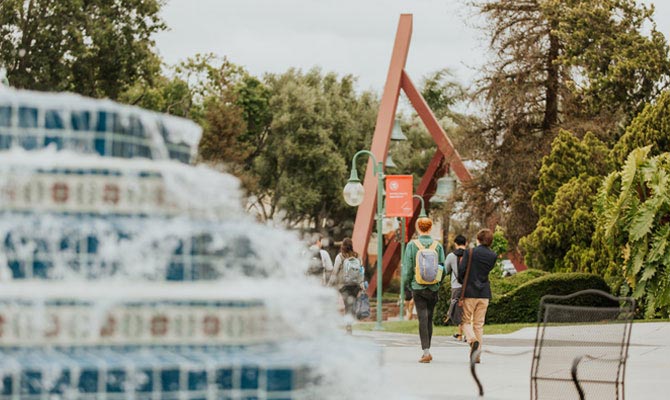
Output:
[{"left": 0, "top": 0, "right": 166, "bottom": 99}]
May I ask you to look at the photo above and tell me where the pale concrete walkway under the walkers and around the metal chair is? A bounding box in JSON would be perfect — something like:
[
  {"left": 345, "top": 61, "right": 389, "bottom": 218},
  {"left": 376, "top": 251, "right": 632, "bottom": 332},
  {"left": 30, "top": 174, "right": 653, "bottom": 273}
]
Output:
[{"left": 354, "top": 323, "right": 670, "bottom": 400}]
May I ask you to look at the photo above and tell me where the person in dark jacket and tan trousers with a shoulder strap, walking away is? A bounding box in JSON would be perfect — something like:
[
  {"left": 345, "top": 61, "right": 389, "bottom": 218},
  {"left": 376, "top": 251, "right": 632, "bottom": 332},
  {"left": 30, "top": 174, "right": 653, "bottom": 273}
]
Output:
[{"left": 458, "top": 229, "right": 498, "bottom": 362}]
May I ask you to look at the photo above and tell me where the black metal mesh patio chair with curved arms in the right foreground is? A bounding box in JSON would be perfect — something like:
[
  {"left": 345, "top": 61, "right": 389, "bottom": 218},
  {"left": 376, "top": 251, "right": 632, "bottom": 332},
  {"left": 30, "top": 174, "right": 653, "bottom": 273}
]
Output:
[{"left": 470, "top": 290, "right": 635, "bottom": 400}]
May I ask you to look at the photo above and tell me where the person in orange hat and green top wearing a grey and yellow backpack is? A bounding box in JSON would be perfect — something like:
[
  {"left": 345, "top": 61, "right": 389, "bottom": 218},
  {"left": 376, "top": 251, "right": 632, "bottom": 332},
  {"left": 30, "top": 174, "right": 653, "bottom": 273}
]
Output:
[{"left": 404, "top": 218, "right": 444, "bottom": 363}]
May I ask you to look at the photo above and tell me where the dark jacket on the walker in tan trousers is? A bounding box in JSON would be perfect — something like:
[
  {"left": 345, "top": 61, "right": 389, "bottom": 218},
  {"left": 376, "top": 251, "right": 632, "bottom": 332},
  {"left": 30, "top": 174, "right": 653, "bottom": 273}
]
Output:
[{"left": 458, "top": 245, "right": 498, "bottom": 299}]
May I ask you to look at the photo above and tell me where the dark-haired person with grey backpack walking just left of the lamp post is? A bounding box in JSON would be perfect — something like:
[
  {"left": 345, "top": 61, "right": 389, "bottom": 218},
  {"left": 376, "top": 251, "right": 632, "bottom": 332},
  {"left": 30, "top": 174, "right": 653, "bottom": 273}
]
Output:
[{"left": 328, "top": 238, "right": 365, "bottom": 334}]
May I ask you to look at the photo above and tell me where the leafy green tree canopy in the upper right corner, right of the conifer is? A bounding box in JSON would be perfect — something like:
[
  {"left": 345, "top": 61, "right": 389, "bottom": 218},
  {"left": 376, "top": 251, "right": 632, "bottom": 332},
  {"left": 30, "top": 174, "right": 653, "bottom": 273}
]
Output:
[{"left": 556, "top": 0, "right": 670, "bottom": 118}]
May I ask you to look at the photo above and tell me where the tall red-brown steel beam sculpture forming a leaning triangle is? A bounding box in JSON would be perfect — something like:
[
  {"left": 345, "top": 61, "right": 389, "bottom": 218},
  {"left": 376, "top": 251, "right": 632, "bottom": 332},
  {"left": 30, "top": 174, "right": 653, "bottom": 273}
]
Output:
[{"left": 352, "top": 14, "right": 472, "bottom": 295}]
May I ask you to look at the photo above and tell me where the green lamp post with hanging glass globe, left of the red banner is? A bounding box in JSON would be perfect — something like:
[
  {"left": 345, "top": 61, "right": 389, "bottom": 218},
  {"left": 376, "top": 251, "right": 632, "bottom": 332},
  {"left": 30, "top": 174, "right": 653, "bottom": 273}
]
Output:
[{"left": 342, "top": 150, "right": 384, "bottom": 330}]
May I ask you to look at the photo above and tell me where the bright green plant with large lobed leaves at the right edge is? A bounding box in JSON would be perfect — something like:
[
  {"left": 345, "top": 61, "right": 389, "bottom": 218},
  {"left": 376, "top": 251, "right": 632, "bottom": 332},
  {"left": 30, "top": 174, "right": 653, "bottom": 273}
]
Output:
[{"left": 598, "top": 146, "right": 670, "bottom": 317}]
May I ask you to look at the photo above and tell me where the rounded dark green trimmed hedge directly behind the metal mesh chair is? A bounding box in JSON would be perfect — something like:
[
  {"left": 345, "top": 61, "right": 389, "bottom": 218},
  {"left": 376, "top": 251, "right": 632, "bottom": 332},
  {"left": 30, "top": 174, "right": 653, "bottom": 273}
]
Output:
[{"left": 486, "top": 273, "right": 610, "bottom": 324}]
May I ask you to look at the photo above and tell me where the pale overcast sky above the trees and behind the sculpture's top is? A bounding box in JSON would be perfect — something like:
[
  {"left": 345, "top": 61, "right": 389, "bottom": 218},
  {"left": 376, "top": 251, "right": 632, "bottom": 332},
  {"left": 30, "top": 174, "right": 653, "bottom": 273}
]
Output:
[{"left": 156, "top": 0, "right": 670, "bottom": 92}]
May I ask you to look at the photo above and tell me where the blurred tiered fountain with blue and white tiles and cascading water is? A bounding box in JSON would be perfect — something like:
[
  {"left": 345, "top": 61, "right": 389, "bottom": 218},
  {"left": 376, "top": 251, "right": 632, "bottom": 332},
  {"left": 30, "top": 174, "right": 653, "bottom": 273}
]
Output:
[{"left": 0, "top": 86, "right": 380, "bottom": 400}]
